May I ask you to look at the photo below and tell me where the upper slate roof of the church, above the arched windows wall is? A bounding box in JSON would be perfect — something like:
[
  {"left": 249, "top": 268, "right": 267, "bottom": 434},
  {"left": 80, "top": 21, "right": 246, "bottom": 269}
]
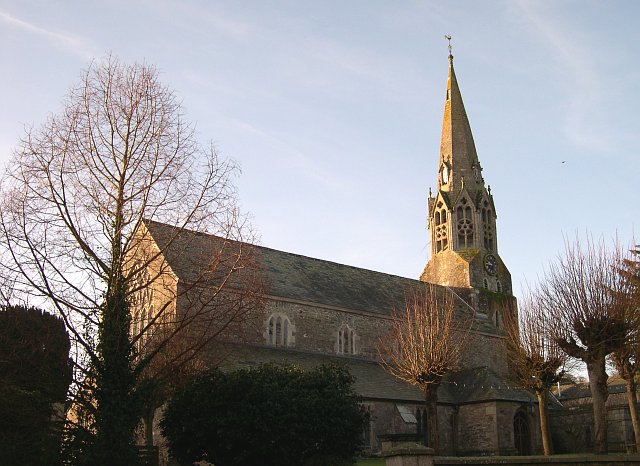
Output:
[{"left": 145, "top": 221, "right": 424, "bottom": 314}]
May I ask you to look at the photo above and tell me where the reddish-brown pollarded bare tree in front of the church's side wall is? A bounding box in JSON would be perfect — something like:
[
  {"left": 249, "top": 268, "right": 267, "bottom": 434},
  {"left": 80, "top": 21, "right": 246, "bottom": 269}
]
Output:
[{"left": 378, "top": 284, "right": 471, "bottom": 451}]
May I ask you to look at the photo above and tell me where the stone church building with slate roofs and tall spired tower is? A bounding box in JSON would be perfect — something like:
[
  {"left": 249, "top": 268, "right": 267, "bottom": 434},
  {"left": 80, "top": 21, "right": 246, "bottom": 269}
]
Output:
[{"left": 138, "top": 55, "right": 540, "bottom": 455}]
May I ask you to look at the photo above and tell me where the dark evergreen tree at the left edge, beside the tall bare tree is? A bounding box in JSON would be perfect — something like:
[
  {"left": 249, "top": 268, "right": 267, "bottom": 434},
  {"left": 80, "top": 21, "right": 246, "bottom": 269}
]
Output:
[{"left": 0, "top": 305, "right": 72, "bottom": 465}]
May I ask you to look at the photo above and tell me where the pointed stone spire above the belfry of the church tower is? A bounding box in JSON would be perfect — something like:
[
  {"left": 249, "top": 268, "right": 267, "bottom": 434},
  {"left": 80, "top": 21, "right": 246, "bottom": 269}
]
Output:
[{"left": 438, "top": 53, "right": 484, "bottom": 196}]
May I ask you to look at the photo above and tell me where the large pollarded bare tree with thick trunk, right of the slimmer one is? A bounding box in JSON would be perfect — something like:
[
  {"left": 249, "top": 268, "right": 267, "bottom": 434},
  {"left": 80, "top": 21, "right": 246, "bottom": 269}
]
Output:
[{"left": 539, "top": 240, "right": 638, "bottom": 454}]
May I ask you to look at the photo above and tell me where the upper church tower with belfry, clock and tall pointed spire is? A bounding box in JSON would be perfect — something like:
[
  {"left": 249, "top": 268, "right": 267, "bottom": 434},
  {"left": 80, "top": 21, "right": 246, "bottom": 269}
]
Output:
[{"left": 420, "top": 49, "right": 511, "bottom": 295}]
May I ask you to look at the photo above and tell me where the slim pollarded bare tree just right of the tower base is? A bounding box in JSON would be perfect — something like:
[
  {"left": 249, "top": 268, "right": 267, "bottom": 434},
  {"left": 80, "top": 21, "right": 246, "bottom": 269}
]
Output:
[{"left": 505, "top": 291, "right": 568, "bottom": 455}]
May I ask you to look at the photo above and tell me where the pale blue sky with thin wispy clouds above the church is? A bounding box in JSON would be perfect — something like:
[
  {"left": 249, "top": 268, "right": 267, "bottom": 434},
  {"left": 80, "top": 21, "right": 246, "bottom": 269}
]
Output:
[{"left": 0, "top": 0, "right": 640, "bottom": 296}]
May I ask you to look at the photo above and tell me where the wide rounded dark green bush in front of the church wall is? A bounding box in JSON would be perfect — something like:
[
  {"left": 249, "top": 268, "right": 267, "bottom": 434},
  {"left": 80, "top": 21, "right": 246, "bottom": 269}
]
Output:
[{"left": 161, "top": 365, "right": 368, "bottom": 466}]
